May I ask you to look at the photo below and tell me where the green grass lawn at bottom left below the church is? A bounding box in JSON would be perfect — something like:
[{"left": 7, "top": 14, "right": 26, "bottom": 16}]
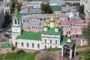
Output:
[{"left": 0, "top": 51, "right": 39, "bottom": 60}]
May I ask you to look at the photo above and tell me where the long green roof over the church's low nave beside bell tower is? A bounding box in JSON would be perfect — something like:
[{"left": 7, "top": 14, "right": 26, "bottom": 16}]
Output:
[{"left": 17, "top": 32, "right": 41, "bottom": 40}]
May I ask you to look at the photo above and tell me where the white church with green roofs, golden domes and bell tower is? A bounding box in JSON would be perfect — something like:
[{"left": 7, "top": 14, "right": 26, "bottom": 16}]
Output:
[{"left": 10, "top": 4, "right": 71, "bottom": 50}]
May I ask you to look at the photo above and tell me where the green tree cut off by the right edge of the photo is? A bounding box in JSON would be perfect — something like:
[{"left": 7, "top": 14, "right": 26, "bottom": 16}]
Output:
[{"left": 82, "top": 22, "right": 90, "bottom": 46}]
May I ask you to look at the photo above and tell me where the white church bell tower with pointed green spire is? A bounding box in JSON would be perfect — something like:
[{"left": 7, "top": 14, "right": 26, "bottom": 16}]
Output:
[{"left": 12, "top": 4, "right": 21, "bottom": 39}]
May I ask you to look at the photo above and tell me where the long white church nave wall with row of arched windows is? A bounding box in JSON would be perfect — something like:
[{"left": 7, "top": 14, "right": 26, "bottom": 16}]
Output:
[{"left": 12, "top": 39, "right": 42, "bottom": 50}]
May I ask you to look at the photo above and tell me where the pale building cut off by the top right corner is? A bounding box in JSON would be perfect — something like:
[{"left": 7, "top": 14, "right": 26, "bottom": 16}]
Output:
[{"left": 80, "top": 0, "right": 90, "bottom": 19}]
